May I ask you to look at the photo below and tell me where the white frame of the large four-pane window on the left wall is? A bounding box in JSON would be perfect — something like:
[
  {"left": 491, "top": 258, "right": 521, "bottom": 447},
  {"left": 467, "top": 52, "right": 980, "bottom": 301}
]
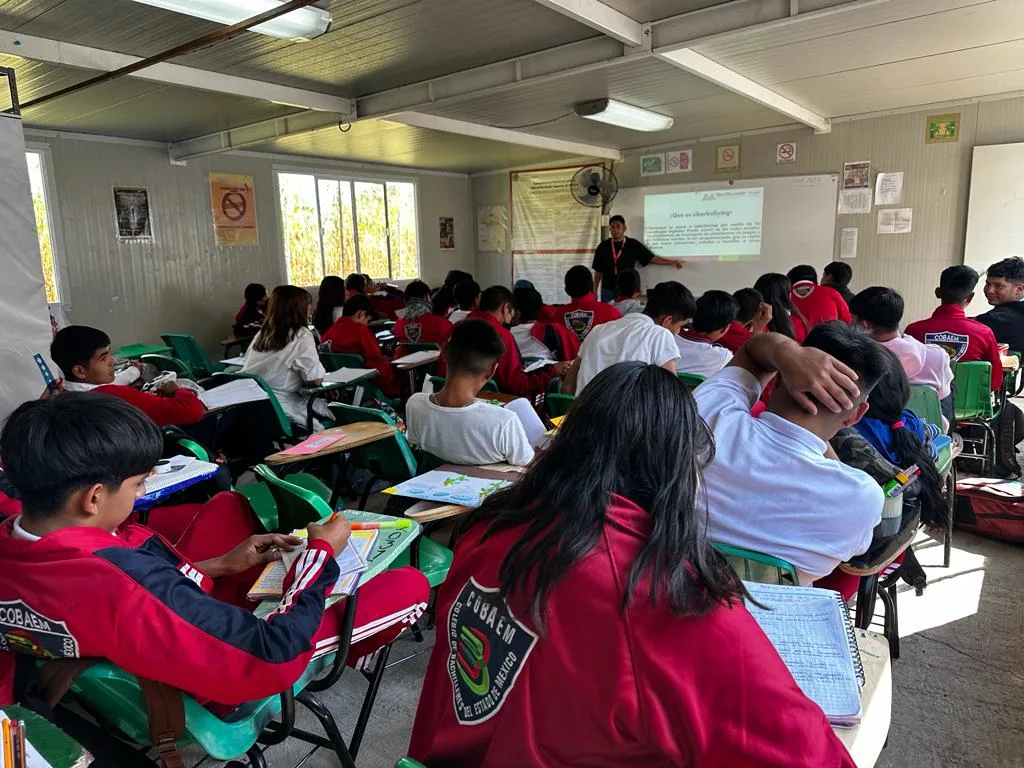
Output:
[{"left": 272, "top": 165, "right": 423, "bottom": 283}]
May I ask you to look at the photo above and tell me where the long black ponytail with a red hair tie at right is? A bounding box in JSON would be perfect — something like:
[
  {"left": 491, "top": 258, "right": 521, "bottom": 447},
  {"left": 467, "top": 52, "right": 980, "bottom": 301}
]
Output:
[{"left": 865, "top": 349, "right": 946, "bottom": 525}]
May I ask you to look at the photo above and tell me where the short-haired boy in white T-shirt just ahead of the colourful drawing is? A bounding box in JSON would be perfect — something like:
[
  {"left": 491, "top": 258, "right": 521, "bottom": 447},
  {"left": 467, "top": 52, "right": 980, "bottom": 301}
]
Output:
[{"left": 406, "top": 319, "right": 543, "bottom": 466}]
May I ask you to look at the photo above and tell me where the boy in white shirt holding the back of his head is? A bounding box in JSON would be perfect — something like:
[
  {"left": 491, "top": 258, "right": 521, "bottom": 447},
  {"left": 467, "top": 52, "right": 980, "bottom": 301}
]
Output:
[{"left": 693, "top": 322, "right": 888, "bottom": 584}]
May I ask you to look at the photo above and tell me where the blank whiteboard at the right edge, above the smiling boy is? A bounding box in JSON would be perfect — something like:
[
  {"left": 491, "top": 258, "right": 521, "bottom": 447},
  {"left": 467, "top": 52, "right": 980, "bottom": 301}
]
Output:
[{"left": 964, "top": 144, "right": 1024, "bottom": 314}]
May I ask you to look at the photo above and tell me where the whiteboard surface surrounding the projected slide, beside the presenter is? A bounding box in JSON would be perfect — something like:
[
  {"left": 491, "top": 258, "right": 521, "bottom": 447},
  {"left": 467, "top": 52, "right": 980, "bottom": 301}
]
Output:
[{"left": 611, "top": 173, "right": 839, "bottom": 296}]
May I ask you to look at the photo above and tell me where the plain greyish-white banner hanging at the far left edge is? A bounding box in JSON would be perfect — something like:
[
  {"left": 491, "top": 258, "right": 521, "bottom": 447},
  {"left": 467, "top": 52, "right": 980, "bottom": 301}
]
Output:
[{"left": 0, "top": 115, "right": 58, "bottom": 421}]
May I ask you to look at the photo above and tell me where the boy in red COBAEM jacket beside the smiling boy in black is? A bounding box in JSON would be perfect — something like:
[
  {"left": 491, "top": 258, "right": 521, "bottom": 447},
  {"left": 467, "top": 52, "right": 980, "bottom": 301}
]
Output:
[{"left": 906, "top": 264, "right": 1002, "bottom": 390}]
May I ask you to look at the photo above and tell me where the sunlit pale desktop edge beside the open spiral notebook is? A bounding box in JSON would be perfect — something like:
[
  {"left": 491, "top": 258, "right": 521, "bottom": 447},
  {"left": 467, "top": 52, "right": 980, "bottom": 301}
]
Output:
[{"left": 833, "top": 630, "right": 893, "bottom": 768}]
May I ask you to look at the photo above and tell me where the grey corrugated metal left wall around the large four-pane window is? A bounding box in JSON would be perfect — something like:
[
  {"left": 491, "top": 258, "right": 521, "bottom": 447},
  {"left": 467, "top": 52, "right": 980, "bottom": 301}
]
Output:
[{"left": 35, "top": 133, "right": 474, "bottom": 351}]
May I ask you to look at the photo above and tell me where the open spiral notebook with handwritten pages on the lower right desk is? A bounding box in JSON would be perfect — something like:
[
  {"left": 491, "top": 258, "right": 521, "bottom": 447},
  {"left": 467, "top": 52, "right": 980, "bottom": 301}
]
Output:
[{"left": 743, "top": 582, "right": 864, "bottom": 728}]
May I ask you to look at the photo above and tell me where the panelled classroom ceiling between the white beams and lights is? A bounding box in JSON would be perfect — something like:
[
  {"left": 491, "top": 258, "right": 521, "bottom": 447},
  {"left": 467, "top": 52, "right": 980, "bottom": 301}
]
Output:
[{"left": 0, "top": 0, "right": 1024, "bottom": 172}]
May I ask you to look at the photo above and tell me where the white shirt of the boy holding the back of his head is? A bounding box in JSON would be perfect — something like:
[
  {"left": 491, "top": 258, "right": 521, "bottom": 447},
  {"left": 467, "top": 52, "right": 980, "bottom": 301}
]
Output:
[{"left": 693, "top": 367, "right": 885, "bottom": 583}]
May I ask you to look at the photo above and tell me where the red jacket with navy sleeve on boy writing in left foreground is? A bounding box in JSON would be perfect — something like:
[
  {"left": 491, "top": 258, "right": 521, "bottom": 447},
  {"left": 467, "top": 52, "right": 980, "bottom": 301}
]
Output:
[{"left": 0, "top": 518, "right": 339, "bottom": 706}]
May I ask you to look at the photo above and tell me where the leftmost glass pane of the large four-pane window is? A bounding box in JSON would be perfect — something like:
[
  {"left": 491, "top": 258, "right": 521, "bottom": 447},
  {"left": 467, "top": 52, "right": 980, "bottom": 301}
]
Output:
[{"left": 278, "top": 173, "right": 324, "bottom": 286}]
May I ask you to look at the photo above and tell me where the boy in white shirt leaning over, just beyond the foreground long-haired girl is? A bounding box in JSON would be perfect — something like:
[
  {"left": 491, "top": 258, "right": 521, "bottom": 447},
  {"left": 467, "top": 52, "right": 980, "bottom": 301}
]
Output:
[{"left": 562, "top": 281, "right": 696, "bottom": 394}]
